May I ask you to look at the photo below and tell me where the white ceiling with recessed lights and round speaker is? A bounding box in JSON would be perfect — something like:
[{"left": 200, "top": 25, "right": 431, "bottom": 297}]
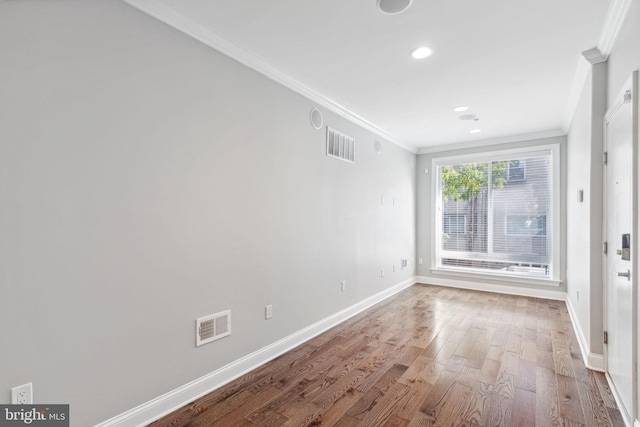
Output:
[{"left": 125, "top": 0, "right": 616, "bottom": 152}]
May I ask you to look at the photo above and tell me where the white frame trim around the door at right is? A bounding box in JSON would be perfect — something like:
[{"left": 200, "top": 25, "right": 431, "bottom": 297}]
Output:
[{"left": 602, "top": 70, "right": 640, "bottom": 426}]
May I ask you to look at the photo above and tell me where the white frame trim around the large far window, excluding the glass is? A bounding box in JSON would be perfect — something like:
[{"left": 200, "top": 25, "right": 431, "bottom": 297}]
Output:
[{"left": 431, "top": 143, "right": 562, "bottom": 286}]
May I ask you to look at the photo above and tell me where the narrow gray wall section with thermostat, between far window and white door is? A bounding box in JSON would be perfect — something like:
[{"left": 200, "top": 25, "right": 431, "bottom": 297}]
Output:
[{"left": 567, "top": 62, "right": 607, "bottom": 370}]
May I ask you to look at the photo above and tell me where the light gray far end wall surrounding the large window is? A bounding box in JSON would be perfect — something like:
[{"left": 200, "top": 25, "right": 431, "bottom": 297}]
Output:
[{"left": 416, "top": 136, "right": 567, "bottom": 299}]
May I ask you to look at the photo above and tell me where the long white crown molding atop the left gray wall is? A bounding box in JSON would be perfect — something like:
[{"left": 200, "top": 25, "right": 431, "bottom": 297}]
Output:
[{"left": 123, "top": 0, "right": 417, "bottom": 154}]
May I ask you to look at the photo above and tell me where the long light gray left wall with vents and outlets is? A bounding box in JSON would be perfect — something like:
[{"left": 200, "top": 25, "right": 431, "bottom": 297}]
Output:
[{"left": 0, "top": 0, "right": 415, "bottom": 426}]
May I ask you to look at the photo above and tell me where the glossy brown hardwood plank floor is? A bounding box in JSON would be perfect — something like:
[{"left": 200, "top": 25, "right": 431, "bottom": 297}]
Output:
[{"left": 152, "top": 285, "right": 624, "bottom": 427}]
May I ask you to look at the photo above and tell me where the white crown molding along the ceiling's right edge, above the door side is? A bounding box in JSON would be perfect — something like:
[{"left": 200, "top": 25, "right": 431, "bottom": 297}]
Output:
[{"left": 562, "top": 0, "right": 632, "bottom": 132}]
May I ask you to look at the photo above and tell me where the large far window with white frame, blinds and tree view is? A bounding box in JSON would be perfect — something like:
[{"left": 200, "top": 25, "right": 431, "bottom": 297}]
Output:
[{"left": 432, "top": 145, "right": 560, "bottom": 283}]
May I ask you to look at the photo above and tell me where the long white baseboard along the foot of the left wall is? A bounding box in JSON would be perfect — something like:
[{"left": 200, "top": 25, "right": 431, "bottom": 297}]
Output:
[{"left": 96, "top": 277, "right": 416, "bottom": 427}]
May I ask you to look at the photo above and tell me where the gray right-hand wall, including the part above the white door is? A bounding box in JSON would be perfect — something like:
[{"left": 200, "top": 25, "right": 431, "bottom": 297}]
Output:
[{"left": 567, "top": 0, "right": 640, "bottom": 370}]
